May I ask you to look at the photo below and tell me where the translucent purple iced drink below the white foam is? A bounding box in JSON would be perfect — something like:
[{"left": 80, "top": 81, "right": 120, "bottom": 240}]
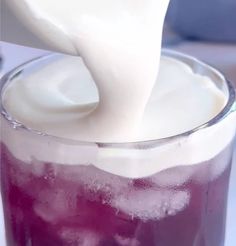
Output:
[{"left": 1, "top": 145, "right": 231, "bottom": 246}]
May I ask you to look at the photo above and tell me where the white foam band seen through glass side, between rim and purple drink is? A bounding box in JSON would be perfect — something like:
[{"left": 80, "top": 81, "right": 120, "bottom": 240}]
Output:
[{"left": 1, "top": 110, "right": 236, "bottom": 179}]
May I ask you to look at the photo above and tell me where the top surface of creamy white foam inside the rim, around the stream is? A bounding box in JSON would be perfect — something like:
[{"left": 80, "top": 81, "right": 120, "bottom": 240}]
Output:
[{"left": 3, "top": 57, "right": 226, "bottom": 142}]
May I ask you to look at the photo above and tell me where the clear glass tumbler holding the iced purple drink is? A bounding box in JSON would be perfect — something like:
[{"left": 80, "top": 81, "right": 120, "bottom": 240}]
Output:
[{"left": 1, "top": 51, "right": 236, "bottom": 246}]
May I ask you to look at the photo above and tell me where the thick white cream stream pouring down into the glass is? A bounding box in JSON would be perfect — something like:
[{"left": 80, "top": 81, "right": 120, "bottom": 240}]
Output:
[{"left": 5, "top": 0, "right": 169, "bottom": 141}]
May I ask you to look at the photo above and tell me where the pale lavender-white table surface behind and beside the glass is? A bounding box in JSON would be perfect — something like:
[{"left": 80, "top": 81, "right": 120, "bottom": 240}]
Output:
[{"left": 0, "top": 41, "right": 236, "bottom": 246}]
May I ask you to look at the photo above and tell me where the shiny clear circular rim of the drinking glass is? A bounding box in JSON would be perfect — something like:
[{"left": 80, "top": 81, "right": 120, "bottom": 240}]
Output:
[{"left": 0, "top": 49, "right": 236, "bottom": 148}]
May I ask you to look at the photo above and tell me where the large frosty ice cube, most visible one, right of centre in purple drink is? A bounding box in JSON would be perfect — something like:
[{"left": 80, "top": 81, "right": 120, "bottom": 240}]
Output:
[{"left": 112, "top": 189, "right": 190, "bottom": 221}]
